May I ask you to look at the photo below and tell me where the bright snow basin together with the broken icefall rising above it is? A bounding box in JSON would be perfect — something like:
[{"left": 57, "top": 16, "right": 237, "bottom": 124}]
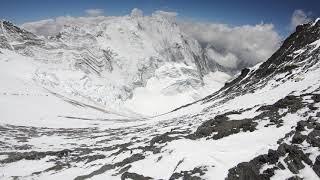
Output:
[{"left": 125, "top": 63, "right": 231, "bottom": 116}]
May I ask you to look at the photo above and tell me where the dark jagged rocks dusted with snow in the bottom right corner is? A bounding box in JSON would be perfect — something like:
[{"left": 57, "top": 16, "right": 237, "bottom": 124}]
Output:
[{"left": 227, "top": 94, "right": 320, "bottom": 180}]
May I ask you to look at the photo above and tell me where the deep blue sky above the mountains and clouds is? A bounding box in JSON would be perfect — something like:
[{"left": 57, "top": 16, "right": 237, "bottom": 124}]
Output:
[{"left": 0, "top": 0, "right": 320, "bottom": 34}]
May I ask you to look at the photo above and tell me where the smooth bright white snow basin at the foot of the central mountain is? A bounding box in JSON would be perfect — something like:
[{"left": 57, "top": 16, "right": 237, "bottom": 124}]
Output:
[{"left": 124, "top": 71, "right": 231, "bottom": 117}]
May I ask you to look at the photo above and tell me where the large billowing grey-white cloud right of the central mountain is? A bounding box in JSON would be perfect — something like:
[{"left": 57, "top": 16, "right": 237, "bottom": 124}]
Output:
[{"left": 181, "top": 22, "right": 281, "bottom": 69}]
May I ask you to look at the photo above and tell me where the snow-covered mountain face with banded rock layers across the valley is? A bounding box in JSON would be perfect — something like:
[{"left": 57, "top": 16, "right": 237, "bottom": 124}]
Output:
[{"left": 1, "top": 9, "right": 231, "bottom": 115}]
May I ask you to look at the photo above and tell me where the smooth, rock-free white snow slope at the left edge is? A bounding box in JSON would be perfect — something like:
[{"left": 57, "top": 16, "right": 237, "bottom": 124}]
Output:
[{"left": 0, "top": 50, "right": 132, "bottom": 127}]
